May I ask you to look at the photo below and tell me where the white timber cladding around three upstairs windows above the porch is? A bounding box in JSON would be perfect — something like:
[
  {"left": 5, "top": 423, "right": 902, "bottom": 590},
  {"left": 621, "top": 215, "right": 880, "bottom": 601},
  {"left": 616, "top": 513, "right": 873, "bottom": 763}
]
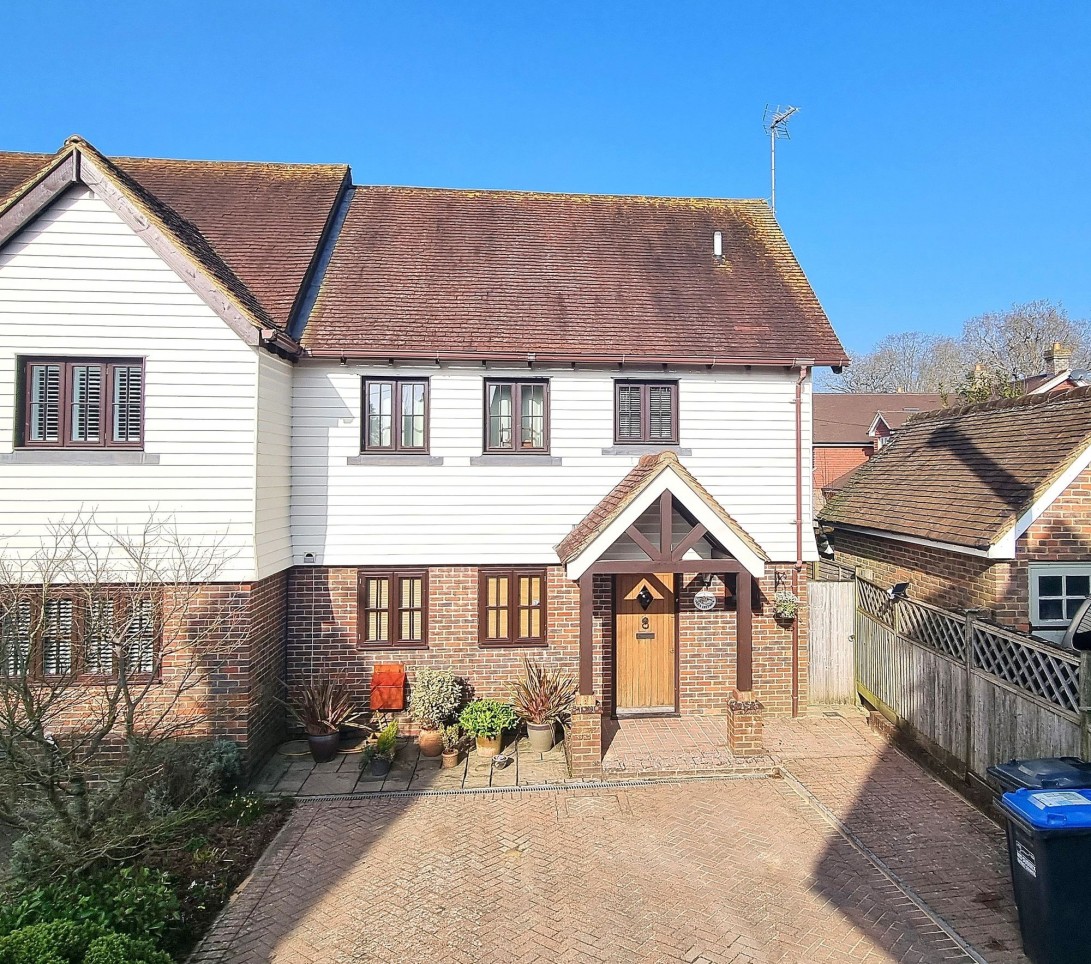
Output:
[{"left": 292, "top": 360, "right": 816, "bottom": 566}]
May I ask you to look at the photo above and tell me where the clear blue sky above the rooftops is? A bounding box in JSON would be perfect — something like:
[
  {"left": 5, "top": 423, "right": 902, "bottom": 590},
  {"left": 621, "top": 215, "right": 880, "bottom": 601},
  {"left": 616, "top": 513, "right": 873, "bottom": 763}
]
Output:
[{"left": 0, "top": 0, "right": 1091, "bottom": 350}]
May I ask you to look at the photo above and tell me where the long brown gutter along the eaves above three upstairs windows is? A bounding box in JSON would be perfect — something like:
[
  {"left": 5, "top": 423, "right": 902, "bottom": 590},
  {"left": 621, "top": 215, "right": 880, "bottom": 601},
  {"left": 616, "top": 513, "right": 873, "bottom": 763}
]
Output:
[{"left": 303, "top": 348, "right": 848, "bottom": 369}]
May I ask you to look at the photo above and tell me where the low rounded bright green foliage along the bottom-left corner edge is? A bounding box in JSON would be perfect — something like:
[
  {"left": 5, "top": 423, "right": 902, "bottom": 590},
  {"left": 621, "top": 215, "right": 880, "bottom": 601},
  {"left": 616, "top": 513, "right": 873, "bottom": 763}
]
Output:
[{"left": 0, "top": 920, "right": 171, "bottom": 964}]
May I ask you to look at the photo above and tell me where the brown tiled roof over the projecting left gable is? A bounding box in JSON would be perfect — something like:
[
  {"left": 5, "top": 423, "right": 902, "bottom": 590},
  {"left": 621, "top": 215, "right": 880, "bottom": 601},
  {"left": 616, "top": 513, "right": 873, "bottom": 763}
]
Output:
[{"left": 0, "top": 137, "right": 349, "bottom": 330}]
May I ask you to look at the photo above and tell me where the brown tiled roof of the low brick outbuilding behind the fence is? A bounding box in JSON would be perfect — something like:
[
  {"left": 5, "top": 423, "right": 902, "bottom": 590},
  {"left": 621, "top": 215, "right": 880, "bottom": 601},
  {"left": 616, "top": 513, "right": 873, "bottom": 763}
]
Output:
[{"left": 819, "top": 388, "right": 1091, "bottom": 557}]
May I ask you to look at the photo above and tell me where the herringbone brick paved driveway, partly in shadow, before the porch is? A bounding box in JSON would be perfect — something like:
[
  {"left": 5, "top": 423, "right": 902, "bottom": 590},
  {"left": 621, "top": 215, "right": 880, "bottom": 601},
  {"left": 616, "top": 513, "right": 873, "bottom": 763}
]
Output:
[{"left": 196, "top": 720, "right": 1022, "bottom": 964}]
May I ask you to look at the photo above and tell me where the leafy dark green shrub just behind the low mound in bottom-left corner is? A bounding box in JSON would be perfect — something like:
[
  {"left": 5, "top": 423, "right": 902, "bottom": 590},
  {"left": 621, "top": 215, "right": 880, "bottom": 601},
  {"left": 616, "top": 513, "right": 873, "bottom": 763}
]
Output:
[{"left": 0, "top": 867, "right": 182, "bottom": 947}]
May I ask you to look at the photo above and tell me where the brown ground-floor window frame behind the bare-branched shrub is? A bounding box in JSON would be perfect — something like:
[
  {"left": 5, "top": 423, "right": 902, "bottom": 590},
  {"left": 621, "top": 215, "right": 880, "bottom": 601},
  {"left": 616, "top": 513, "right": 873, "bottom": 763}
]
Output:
[{"left": 0, "top": 590, "right": 163, "bottom": 685}]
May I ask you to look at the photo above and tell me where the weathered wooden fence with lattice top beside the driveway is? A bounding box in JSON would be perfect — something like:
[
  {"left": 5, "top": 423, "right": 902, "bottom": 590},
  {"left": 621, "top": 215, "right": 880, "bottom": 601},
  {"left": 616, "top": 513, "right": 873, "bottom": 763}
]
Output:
[{"left": 854, "top": 579, "right": 1086, "bottom": 780}]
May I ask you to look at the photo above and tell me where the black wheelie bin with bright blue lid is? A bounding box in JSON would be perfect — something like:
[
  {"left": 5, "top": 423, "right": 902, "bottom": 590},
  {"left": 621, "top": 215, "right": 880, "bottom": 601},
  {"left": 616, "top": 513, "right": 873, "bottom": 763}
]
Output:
[{"left": 999, "top": 790, "right": 1091, "bottom": 964}]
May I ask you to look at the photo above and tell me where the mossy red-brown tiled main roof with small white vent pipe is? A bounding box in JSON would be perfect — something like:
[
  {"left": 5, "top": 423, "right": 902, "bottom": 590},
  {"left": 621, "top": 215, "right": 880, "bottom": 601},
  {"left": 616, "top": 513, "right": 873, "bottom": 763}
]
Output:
[{"left": 301, "top": 186, "right": 847, "bottom": 365}]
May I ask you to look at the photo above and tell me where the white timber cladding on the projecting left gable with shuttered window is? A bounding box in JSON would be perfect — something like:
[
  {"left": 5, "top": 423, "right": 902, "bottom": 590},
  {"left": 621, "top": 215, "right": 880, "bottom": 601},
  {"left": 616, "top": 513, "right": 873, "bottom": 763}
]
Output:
[{"left": 0, "top": 186, "right": 261, "bottom": 580}]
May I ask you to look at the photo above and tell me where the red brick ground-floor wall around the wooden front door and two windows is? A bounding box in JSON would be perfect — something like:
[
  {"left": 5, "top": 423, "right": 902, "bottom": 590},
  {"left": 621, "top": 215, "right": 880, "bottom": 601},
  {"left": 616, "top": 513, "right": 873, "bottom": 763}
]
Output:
[{"left": 287, "top": 566, "right": 807, "bottom": 715}]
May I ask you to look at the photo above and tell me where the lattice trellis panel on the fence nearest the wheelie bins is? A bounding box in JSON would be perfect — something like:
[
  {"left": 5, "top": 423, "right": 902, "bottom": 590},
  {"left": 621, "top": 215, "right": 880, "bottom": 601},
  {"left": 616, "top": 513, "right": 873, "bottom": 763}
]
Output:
[{"left": 973, "top": 623, "right": 1080, "bottom": 713}]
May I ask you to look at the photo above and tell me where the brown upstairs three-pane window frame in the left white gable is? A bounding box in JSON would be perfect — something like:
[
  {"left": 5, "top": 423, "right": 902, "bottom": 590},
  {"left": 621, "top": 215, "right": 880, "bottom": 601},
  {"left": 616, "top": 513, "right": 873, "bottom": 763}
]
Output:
[{"left": 16, "top": 356, "right": 147, "bottom": 451}]
